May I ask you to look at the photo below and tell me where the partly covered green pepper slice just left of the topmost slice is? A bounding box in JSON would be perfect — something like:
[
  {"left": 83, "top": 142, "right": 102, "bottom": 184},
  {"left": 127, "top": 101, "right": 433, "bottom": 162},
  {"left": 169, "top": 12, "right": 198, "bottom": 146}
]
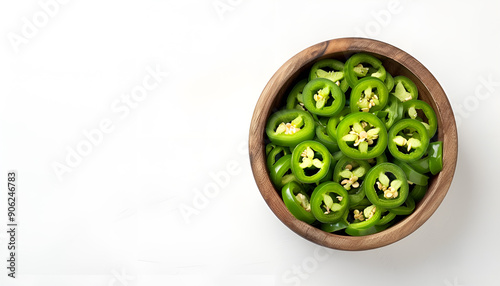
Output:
[{"left": 309, "top": 59, "right": 349, "bottom": 92}]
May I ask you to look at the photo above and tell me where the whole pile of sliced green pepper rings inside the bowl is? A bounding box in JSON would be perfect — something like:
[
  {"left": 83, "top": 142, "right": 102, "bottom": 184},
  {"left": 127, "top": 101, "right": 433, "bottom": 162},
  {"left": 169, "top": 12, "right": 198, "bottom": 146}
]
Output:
[{"left": 266, "top": 53, "right": 443, "bottom": 236}]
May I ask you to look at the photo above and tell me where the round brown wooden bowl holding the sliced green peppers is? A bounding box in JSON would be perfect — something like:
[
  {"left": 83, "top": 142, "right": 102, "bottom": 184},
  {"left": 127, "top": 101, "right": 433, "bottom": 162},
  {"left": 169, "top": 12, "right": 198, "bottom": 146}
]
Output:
[{"left": 249, "top": 38, "right": 458, "bottom": 250}]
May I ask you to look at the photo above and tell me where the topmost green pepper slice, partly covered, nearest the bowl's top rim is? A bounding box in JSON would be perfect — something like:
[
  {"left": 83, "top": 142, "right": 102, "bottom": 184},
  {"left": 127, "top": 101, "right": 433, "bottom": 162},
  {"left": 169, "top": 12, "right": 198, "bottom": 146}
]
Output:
[{"left": 344, "top": 53, "right": 387, "bottom": 88}]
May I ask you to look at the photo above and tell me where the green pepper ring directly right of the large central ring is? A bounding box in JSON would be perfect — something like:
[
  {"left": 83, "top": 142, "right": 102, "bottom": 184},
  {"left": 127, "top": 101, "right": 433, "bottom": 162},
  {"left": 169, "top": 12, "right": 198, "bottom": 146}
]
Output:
[{"left": 386, "top": 119, "right": 429, "bottom": 162}]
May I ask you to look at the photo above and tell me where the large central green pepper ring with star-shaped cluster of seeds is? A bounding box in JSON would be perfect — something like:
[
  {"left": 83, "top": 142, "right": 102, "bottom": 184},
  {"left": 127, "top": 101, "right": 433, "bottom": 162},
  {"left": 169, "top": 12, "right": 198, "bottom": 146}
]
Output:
[{"left": 337, "top": 112, "right": 387, "bottom": 159}]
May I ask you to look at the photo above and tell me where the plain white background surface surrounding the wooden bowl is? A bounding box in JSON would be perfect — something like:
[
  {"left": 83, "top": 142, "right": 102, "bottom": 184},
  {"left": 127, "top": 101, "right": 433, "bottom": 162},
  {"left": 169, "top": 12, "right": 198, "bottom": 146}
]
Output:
[{"left": 0, "top": 0, "right": 500, "bottom": 286}]
